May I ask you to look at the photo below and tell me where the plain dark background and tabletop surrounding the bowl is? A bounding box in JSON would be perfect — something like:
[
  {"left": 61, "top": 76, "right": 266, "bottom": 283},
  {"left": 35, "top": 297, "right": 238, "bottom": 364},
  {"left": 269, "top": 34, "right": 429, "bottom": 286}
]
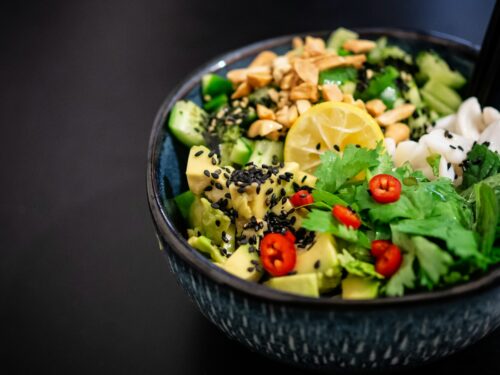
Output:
[{"left": 0, "top": 0, "right": 500, "bottom": 375}]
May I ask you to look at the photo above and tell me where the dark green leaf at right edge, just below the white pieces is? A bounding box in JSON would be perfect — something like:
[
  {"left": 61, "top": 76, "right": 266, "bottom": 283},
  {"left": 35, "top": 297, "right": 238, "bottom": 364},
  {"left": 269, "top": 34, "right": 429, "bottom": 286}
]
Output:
[{"left": 461, "top": 143, "right": 500, "bottom": 189}]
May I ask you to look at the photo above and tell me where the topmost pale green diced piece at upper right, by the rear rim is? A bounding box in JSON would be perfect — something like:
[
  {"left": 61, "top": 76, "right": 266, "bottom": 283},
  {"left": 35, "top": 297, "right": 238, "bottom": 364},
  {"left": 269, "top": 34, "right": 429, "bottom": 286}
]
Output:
[{"left": 417, "top": 52, "right": 466, "bottom": 89}]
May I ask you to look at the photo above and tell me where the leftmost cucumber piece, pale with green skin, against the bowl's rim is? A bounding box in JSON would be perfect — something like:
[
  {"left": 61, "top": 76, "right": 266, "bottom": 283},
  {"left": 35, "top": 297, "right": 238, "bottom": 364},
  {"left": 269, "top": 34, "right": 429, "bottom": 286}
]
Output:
[{"left": 168, "top": 100, "right": 208, "bottom": 147}]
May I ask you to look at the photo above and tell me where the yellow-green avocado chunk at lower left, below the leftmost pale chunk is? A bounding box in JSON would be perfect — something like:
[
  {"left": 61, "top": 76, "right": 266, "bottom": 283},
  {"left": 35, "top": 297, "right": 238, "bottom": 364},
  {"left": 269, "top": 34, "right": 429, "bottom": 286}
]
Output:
[{"left": 189, "top": 197, "right": 235, "bottom": 254}]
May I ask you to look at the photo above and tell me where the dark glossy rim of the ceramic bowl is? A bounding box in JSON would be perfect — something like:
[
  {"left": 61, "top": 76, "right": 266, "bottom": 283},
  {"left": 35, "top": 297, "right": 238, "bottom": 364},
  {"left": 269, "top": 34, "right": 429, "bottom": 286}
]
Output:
[{"left": 146, "top": 28, "right": 500, "bottom": 310}]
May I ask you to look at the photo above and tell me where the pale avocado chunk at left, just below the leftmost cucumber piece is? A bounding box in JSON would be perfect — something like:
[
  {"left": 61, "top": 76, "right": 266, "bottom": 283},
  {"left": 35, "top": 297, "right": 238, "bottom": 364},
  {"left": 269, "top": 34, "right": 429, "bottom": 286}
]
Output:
[{"left": 186, "top": 146, "right": 219, "bottom": 195}]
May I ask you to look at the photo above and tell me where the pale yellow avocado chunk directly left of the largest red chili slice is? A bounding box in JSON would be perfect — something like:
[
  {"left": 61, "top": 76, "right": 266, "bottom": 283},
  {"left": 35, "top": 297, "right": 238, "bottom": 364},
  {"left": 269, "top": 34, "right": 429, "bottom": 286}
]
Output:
[{"left": 223, "top": 245, "right": 263, "bottom": 282}]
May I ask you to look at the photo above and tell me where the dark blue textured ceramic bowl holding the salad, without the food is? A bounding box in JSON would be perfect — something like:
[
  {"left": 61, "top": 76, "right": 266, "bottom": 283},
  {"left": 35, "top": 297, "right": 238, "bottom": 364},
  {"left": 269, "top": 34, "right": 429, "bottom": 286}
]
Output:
[{"left": 147, "top": 29, "right": 500, "bottom": 371}]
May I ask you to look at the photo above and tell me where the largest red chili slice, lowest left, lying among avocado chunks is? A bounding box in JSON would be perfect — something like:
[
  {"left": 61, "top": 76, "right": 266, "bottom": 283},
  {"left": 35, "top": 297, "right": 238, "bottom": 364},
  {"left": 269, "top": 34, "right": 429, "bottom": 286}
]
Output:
[{"left": 260, "top": 233, "right": 297, "bottom": 276}]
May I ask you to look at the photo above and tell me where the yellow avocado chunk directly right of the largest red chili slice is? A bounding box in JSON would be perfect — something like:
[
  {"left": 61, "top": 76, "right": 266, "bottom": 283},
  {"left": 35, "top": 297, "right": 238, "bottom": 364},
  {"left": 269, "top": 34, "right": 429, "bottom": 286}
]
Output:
[{"left": 294, "top": 233, "right": 342, "bottom": 293}]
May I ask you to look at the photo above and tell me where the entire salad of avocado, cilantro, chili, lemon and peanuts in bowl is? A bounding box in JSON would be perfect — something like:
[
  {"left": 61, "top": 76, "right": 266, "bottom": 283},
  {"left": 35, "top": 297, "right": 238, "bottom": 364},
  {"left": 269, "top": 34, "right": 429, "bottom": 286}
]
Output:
[{"left": 168, "top": 28, "right": 500, "bottom": 299}]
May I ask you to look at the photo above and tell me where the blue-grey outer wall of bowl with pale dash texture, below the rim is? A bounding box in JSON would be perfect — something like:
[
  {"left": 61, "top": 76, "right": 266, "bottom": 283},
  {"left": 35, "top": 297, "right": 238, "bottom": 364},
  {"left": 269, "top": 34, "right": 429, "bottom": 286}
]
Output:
[{"left": 164, "top": 239, "right": 500, "bottom": 372}]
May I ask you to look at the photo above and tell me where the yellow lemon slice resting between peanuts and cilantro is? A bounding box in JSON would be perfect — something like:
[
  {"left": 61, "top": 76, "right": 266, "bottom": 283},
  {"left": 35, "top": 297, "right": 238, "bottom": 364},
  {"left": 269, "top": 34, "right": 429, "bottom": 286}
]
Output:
[{"left": 284, "top": 102, "right": 384, "bottom": 173}]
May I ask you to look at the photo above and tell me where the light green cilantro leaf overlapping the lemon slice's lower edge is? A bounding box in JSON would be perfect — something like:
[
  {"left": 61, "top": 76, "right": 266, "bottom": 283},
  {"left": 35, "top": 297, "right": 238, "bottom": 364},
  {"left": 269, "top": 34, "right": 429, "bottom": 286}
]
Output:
[{"left": 315, "top": 145, "right": 379, "bottom": 193}]
